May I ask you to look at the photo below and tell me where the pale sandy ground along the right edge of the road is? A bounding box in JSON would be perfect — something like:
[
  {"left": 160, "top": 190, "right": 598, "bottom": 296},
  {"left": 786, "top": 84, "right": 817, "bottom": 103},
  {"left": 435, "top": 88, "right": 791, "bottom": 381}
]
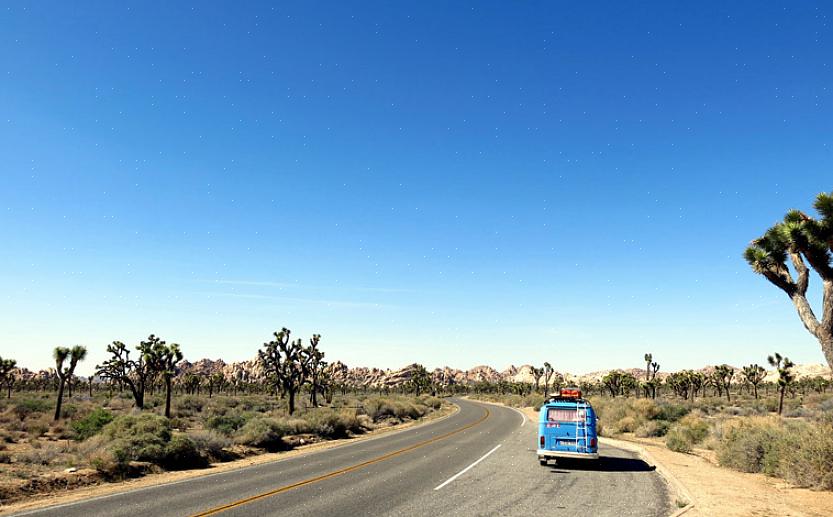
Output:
[{"left": 524, "top": 408, "right": 833, "bottom": 517}]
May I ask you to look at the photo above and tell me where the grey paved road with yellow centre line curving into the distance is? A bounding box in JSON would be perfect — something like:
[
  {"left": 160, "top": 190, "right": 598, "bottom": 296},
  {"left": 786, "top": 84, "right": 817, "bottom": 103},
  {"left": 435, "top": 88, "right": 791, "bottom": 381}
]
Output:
[{"left": 14, "top": 400, "right": 671, "bottom": 517}]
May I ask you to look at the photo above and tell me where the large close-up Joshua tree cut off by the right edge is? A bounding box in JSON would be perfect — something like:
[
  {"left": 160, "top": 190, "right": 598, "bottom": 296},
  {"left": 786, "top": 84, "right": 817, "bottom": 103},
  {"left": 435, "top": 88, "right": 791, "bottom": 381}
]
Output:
[{"left": 744, "top": 192, "right": 833, "bottom": 370}]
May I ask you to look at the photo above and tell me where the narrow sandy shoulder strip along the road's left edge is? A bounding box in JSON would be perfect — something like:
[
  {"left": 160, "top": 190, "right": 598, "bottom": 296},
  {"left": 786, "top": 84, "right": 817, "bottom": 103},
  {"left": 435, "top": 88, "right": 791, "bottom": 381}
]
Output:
[{"left": 0, "top": 404, "right": 460, "bottom": 515}]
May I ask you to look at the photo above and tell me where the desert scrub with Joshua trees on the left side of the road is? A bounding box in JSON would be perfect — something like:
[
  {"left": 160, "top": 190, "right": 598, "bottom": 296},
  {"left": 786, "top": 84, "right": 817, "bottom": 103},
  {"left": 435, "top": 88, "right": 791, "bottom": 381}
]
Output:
[{"left": 0, "top": 329, "right": 442, "bottom": 503}]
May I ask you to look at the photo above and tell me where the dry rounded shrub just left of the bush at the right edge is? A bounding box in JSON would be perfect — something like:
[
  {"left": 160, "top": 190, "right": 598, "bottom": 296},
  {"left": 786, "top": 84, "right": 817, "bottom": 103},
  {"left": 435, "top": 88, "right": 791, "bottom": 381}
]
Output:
[{"left": 716, "top": 418, "right": 783, "bottom": 475}]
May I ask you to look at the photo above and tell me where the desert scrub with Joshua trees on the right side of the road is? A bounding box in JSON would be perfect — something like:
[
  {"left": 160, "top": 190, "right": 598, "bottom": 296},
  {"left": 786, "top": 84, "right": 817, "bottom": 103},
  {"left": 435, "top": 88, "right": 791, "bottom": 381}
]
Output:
[{"left": 470, "top": 353, "right": 833, "bottom": 490}]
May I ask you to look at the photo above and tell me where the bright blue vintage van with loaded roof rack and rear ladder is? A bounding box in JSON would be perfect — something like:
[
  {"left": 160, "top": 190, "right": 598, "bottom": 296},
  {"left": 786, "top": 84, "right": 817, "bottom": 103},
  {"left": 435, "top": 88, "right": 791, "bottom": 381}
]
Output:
[{"left": 538, "top": 388, "right": 599, "bottom": 465}]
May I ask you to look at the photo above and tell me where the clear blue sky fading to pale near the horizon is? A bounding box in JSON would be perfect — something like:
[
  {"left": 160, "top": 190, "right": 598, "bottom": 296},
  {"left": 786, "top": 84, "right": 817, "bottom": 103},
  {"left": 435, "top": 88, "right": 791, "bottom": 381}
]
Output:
[{"left": 0, "top": 1, "right": 833, "bottom": 372}]
